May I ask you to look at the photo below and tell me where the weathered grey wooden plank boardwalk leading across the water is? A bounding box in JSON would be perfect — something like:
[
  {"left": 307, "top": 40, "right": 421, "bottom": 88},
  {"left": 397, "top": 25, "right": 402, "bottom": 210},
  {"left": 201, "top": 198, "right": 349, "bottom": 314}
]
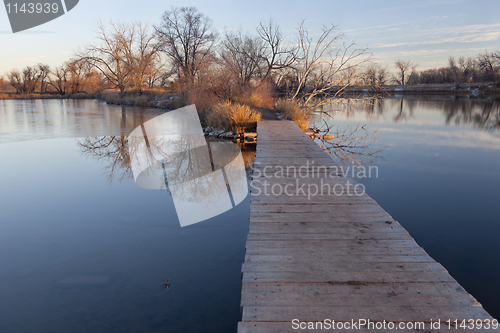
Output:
[{"left": 238, "top": 121, "right": 499, "bottom": 333}]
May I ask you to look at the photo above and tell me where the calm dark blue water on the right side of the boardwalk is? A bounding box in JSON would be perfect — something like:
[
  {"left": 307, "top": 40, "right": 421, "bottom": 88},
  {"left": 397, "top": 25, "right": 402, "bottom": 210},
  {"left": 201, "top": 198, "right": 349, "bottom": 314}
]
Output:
[{"left": 316, "top": 97, "right": 500, "bottom": 318}]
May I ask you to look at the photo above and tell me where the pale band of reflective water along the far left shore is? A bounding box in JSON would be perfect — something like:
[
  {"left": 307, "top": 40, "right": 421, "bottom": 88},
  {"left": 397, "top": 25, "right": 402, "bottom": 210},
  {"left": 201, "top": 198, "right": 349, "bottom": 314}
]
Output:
[{"left": 0, "top": 100, "right": 164, "bottom": 143}]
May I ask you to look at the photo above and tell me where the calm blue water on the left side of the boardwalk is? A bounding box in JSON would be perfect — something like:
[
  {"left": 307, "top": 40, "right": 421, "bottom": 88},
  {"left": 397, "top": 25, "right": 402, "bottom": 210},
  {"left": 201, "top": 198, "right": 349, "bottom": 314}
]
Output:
[{"left": 0, "top": 100, "right": 249, "bottom": 332}]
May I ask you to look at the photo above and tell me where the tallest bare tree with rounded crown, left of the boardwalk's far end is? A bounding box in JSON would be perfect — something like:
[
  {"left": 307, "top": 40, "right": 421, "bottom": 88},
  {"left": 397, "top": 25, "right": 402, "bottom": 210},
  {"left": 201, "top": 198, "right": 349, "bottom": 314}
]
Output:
[{"left": 155, "top": 7, "right": 217, "bottom": 83}]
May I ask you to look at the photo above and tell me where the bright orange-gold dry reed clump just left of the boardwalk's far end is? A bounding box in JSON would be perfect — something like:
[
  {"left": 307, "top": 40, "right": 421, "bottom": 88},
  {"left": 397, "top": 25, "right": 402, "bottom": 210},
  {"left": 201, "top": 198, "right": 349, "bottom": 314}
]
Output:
[{"left": 207, "top": 102, "right": 261, "bottom": 133}]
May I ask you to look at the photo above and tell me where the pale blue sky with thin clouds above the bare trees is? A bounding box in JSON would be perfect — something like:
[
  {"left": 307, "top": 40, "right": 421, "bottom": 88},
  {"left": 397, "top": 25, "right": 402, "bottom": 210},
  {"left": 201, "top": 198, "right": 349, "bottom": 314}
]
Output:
[{"left": 0, "top": 0, "right": 500, "bottom": 75}]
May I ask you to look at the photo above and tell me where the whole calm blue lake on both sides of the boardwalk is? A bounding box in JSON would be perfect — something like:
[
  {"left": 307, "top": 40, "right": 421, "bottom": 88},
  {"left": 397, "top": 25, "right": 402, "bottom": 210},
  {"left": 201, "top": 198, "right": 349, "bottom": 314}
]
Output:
[{"left": 0, "top": 97, "right": 500, "bottom": 332}]
